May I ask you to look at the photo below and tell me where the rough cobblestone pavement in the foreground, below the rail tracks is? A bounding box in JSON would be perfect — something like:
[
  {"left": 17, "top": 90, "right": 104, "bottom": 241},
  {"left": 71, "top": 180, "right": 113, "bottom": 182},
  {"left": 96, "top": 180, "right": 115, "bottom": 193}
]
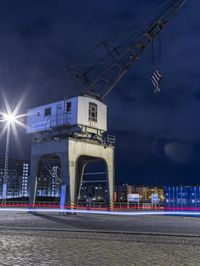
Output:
[{"left": 0, "top": 232, "right": 200, "bottom": 266}]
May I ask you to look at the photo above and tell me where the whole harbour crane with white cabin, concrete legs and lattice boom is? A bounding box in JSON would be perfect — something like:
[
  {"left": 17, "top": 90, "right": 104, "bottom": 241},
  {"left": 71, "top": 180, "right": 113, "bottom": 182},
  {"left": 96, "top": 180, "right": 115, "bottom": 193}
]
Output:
[{"left": 27, "top": 0, "right": 185, "bottom": 210}]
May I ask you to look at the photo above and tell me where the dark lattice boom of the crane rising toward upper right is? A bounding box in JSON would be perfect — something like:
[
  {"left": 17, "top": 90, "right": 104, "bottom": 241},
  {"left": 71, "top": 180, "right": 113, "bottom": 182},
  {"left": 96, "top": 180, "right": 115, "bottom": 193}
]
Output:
[{"left": 68, "top": 0, "right": 186, "bottom": 100}]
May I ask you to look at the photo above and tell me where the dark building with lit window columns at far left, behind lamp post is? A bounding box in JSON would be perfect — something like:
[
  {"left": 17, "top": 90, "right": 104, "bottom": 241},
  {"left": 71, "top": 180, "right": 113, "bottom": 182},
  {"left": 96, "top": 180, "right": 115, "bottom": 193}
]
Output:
[{"left": 0, "top": 158, "right": 30, "bottom": 198}]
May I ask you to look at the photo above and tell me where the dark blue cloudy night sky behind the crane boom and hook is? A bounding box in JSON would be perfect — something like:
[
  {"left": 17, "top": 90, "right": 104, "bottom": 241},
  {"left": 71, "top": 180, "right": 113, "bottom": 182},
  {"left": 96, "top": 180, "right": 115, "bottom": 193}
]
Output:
[{"left": 0, "top": 0, "right": 200, "bottom": 185}]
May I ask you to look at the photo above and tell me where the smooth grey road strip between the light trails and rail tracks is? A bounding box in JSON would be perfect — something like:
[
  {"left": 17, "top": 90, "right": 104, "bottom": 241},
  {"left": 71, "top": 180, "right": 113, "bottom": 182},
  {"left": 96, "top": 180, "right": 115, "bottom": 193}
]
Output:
[{"left": 0, "top": 212, "right": 200, "bottom": 235}]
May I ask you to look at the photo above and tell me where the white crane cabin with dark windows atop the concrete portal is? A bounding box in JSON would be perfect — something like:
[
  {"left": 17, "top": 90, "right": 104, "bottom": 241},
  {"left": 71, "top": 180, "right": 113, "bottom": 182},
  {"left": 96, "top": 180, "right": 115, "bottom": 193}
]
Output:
[{"left": 27, "top": 96, "right": 107, "bottom": 140}]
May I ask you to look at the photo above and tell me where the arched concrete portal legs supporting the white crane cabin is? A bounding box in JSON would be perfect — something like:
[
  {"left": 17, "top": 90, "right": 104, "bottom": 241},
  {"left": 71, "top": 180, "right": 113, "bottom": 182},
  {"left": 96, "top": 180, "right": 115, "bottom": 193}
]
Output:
[{"left": 30, "top": 138, "right": 114, "bottom": 210}]
